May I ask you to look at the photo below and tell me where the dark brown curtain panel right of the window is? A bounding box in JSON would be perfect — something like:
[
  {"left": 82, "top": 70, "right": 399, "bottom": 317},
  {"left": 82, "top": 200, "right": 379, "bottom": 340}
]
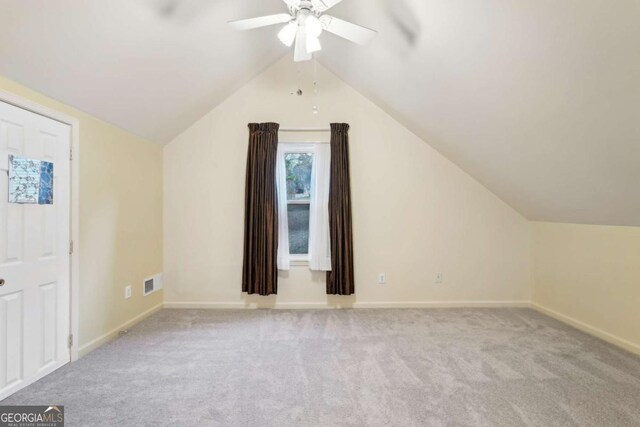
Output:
[{"left": 327, "top": 123, "right": 355, "bottom": 295}]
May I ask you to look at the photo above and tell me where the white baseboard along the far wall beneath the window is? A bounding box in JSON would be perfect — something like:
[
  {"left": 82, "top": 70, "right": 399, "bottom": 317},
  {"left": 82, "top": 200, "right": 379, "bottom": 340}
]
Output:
[{"left": 164, "top": 301, "right": 531, "bottom": 310}]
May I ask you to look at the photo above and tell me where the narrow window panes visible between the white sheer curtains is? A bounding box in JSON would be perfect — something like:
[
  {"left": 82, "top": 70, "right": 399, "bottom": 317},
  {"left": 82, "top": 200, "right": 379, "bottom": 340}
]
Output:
[{"left": 284, "top": 153, "right": 314, "bottom": 255}]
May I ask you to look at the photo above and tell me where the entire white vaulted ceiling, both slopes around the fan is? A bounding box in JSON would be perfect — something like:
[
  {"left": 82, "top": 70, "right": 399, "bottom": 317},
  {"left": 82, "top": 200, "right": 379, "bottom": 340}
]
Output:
[{"left": 0, "top": 0, "right": 640, "bottom": 226}]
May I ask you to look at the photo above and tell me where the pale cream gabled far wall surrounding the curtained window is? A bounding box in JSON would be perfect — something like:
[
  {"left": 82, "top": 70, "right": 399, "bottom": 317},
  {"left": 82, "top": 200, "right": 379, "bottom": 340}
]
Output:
[{"left": 164, "top": 57, "right": 531, "bottom": 306}]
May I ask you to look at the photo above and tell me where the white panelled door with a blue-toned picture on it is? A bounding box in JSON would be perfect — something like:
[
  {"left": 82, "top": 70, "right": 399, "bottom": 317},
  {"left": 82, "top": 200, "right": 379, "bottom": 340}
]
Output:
[{"left": 0, "top": 101, "right": 70, "bottom": 400}]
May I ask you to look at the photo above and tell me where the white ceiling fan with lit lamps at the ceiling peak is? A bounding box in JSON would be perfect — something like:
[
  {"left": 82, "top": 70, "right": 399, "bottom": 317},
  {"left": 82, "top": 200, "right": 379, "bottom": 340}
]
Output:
[{"left": 229, "top": 0, "right": 378, "bottom": 62}]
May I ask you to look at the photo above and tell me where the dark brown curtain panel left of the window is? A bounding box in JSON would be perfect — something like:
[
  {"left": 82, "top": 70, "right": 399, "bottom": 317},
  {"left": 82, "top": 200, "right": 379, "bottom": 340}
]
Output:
[{"left": 242, "top": 123, "right": 280, "bottom": 295}]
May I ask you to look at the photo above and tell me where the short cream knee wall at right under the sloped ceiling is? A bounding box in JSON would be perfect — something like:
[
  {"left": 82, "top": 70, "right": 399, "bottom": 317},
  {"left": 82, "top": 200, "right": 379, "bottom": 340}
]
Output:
[{"left": 533, "top": 223, "right": 640, "bottom": 354}]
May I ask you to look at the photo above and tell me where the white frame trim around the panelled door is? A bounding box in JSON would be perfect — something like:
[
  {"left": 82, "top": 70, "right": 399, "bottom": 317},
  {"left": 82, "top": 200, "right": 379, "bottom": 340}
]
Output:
[{"left": 0, "top": 89, "right": 80, "bottom": 362}]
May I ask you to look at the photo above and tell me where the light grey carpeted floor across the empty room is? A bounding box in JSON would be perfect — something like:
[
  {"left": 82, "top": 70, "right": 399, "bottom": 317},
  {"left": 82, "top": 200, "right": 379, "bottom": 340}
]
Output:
[{"left": 2, "top": 309, "right": 640, "bottom": 427}]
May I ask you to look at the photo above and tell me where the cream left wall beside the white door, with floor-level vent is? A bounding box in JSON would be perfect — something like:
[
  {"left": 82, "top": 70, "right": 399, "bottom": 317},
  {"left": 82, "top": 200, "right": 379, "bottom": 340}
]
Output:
[{"left": 0, "top": 77, "right": 162, "bottom": 353}]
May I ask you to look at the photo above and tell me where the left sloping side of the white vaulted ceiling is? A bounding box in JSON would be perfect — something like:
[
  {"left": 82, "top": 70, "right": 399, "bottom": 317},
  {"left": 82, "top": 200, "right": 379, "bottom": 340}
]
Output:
[{"left": 0, "top": 0, "right": 286, "bottom": 143}]
